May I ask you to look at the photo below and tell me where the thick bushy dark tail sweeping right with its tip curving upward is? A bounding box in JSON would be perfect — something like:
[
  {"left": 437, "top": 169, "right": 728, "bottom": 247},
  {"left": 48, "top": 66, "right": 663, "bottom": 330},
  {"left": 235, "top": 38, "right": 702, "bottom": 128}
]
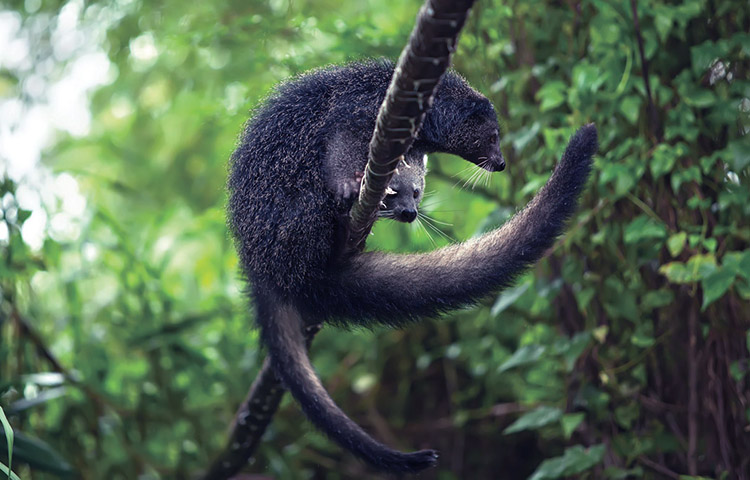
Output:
[{"left": 317, "top": 124, "right": 598, "bottom": 326}]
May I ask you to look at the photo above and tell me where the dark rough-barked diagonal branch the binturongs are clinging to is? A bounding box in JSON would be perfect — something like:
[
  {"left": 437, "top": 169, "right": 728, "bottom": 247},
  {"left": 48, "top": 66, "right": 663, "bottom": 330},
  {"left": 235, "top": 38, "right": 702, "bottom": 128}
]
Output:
[{"left": 202, "top": 0, "right": 474, "bottom": 480}]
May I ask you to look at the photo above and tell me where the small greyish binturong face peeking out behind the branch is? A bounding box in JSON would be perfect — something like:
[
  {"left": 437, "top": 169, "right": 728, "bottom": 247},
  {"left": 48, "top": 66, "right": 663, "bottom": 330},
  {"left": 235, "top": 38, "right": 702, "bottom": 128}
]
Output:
[{"left": 378, "top": 155, "right": 427, "bottom": 223}]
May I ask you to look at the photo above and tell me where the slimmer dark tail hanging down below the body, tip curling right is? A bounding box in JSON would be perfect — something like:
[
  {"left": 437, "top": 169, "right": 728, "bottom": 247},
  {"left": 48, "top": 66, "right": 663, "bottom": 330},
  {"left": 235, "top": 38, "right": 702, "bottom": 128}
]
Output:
[{"left": 255, "top": 294, "right": 437, "bottom": 473}]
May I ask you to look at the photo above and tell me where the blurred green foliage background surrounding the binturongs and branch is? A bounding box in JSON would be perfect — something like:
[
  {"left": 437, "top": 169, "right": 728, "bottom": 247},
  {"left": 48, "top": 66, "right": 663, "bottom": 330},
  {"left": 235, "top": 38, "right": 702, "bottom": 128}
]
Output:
[{"left": 0, "top": 0, "right": 750, "bottom": 480}]
